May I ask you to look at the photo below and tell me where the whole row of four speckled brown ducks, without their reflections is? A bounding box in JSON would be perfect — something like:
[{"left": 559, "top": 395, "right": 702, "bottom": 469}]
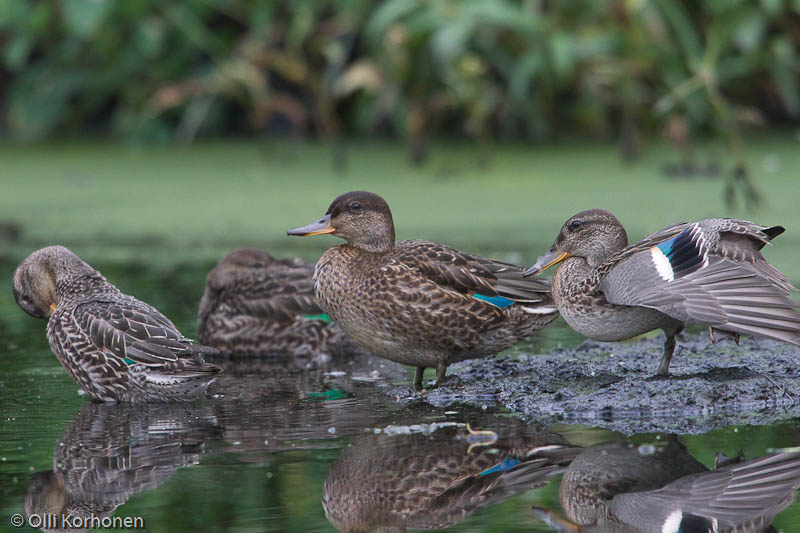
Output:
[{"left": 13, "top": 191, "right": 800, "bottom": 402}]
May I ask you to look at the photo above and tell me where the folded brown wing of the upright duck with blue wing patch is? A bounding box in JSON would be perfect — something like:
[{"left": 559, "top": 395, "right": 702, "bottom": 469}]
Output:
[{"left": 398, "top": 241, "right": 550, "bottom": 303}]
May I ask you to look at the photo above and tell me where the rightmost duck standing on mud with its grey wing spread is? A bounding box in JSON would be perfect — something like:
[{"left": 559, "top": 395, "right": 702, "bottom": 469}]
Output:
[{"left": 525, "top": 209, "right": 800, "bottom": 376}]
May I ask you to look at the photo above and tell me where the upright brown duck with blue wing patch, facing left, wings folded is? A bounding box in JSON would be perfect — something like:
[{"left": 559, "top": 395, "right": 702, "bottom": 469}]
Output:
[{"left": 288, "top": 191, "right": 558, "bottom": 391}]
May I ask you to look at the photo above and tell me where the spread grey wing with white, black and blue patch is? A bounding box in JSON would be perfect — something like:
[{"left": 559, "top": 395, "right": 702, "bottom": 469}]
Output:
[{"left": 595, "top": 219, "right": 800, "bottom": 344}]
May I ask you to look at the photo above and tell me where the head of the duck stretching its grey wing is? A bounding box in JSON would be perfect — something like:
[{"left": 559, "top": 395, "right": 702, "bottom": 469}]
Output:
[{"left": 525, "top": 209, "right": 628, "bottom": 276}]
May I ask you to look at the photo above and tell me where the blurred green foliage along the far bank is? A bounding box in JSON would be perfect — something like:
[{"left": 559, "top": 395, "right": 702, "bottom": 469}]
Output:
[{"left": 0, "top": 0, "right": 800, "bottom": 153}]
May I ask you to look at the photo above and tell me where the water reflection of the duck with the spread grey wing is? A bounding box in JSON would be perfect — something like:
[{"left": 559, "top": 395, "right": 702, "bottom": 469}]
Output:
[{"left": 536, "top": 437, "right": 800, "bottom": 533}]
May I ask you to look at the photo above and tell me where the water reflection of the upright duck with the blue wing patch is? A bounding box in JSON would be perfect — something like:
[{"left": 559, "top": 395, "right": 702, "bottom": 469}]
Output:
[{"left": 322, "top": 418, "right": 580, "bottom": 532}]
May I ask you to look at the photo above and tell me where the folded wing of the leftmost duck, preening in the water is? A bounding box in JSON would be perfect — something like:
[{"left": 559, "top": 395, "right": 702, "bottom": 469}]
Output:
[{"left": 75, "top": 300, "right": 207, "bottom": 366}]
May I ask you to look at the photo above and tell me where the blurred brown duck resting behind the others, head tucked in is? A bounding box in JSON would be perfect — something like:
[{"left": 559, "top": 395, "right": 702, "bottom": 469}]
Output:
[{"left": 197, "top": 247, "right": 360, "bottom": 357}]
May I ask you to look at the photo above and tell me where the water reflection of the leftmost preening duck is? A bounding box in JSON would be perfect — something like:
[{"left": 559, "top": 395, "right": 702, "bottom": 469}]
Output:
[{"left": 25, "top": 403, "right": 218, "bottom": 531}]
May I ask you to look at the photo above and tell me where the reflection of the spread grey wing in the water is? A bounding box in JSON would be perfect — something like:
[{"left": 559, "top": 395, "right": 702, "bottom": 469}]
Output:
[{"left": 611, "top": 453, "right": 800, "bottom": 531}]
